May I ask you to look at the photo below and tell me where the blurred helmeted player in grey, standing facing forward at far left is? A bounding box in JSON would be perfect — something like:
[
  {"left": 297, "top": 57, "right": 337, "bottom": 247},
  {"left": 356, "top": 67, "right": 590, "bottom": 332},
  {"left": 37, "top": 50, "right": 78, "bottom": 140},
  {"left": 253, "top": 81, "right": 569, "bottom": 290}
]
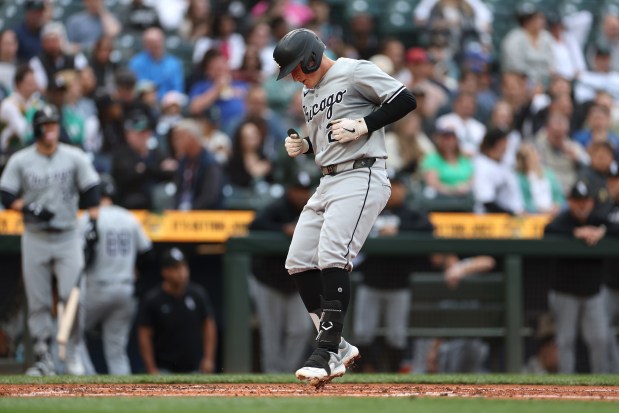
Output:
[{"left": 0, "top": 105, "right": 99, "bottom": 376}]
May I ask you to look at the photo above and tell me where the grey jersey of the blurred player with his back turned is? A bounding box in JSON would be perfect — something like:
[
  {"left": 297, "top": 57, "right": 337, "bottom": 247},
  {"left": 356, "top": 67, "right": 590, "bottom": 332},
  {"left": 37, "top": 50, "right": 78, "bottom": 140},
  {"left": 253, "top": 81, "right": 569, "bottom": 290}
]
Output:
[{"left": 80, "top": 205, "right": 152, "bottom": 284}]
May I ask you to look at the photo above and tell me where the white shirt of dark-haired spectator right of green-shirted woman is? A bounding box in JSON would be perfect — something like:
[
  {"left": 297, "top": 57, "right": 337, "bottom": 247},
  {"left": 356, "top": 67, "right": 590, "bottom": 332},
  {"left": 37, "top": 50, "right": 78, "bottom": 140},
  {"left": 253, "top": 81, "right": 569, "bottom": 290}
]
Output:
[{"left": 473, "top": 154, "right": 524, "bottom": 214}]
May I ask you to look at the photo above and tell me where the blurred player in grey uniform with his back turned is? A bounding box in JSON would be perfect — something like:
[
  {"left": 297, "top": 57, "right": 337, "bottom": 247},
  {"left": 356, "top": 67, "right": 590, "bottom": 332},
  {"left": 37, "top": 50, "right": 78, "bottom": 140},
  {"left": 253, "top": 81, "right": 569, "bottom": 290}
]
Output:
[{"left": 80, "top": 176, "right": 152, "bottom": 374}]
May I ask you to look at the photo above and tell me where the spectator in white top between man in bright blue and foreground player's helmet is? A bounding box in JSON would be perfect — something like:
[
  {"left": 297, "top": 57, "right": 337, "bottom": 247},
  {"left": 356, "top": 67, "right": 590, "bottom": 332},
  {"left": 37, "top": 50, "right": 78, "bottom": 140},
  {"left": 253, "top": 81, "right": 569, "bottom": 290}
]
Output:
[{"left": 193, "top": 13, "right": 245, "bottom": 70}]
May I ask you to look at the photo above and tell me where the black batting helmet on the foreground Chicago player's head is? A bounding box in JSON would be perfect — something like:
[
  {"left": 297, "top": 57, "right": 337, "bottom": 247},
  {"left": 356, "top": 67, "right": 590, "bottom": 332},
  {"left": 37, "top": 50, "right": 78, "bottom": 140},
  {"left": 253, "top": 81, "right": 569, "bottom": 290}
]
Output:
[{"left": 273, "top": 29, "right": 325, "bottom": 80}]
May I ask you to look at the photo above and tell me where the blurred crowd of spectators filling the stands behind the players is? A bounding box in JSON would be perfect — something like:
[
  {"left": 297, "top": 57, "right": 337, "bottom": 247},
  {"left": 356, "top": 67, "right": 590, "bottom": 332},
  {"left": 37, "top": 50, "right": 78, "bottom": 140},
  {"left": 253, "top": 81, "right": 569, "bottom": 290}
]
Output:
[{"left": 0, "top": 0, "right": 619, "bottom": 374}]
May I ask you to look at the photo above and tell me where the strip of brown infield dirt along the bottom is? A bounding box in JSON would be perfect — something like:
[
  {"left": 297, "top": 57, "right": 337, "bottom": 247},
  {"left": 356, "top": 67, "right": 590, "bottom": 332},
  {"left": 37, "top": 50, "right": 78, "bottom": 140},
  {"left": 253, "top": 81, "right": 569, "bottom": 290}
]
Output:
[{"left": 0, "top": 383, "right": 619, "bottom": 401}]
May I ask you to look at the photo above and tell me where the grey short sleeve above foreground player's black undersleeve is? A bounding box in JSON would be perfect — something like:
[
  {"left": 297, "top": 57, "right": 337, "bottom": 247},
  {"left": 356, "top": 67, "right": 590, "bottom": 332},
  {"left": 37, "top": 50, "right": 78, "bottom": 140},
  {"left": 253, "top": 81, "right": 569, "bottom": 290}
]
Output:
[{"left": 352, "top": 60, "right": 406, "bottom": 106}]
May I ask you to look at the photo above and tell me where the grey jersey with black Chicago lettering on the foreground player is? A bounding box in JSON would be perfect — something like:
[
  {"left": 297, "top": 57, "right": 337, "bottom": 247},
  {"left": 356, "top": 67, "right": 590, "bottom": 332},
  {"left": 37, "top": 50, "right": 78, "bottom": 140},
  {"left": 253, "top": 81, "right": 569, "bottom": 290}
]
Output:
[{"left": 302, "top": 58, "right": 405, "bottom": 167}]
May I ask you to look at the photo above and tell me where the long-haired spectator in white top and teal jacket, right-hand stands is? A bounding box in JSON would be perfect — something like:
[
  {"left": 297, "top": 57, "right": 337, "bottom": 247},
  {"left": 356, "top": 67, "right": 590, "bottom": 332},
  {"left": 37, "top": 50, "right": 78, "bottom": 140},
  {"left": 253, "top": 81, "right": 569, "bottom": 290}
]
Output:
[{"left": 516, "top": 142, "right": 565, "bottom": 215}]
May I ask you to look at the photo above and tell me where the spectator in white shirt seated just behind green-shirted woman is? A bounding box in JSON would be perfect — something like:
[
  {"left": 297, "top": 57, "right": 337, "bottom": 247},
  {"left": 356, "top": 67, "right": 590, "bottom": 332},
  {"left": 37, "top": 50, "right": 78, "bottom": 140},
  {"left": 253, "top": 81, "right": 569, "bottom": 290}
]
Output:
[{"left": 436, "top": 92, "right": 486, "bottom": 156}]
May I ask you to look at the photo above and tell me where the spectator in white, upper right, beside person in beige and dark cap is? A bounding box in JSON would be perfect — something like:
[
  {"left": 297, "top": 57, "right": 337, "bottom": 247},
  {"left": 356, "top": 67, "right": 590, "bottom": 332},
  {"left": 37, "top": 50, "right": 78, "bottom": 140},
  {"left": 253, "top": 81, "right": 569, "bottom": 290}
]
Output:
[{"left": 546, "top": 10, "right": 587, "bottom": 81}]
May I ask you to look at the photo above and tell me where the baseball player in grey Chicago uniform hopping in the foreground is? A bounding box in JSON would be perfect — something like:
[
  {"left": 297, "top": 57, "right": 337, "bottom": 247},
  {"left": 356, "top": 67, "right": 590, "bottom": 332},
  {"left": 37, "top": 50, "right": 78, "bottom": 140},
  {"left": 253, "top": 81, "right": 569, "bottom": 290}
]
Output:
[{"left": 273, "top": 29, "right": 417, "bottom": 388}]
